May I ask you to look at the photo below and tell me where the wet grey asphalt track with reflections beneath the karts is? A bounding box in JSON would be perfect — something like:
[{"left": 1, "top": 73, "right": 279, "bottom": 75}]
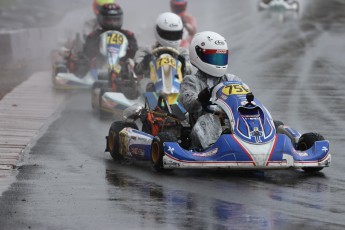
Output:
[{"left": 0, "top": 0, "right": 345, "bottom": 229}]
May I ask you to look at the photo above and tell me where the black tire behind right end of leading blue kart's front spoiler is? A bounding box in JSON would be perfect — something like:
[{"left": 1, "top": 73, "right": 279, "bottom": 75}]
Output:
[{"left": 297, "top": 133, "right": 325, "bottom": 172}]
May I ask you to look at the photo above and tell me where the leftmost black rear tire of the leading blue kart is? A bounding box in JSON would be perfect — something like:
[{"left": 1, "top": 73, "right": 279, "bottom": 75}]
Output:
[{"left": 107, "top": 121, "right": 138, "bottom": 161}]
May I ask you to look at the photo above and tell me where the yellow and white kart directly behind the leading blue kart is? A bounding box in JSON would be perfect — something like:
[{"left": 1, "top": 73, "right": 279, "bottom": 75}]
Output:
[{"left": 93, "top": 47, "right": 185, "bottom": 115}]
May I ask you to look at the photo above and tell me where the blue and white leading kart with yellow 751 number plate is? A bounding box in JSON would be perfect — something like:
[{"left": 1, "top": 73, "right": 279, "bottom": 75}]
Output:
[{"left": 107, "top": 81, "right": 331, "bottom": 172}]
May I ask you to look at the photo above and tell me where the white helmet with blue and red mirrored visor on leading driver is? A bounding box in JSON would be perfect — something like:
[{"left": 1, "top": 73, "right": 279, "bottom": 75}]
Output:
[{"left": 189, "top": 31, "right": 229, "bottom": 77}]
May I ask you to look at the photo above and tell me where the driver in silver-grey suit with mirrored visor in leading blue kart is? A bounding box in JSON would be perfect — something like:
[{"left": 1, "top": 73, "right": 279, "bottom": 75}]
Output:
[{"left": 179, "top": 31, "right": 242, "bottom": 149}]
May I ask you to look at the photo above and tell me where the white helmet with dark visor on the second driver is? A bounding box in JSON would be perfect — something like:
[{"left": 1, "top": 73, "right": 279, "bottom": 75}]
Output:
[{"left": 155, "top": 12, "right": 183, "bottom": 49}]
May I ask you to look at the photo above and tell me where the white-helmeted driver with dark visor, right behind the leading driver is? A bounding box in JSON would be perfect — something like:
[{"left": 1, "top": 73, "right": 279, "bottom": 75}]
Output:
[{"left": 134, "top": 12, "right": 191, "bottom": 77}]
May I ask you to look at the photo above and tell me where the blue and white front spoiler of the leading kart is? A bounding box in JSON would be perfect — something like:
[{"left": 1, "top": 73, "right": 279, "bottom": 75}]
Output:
[{"left": 163, "top": 134, "right": 331, "bottom": 170}]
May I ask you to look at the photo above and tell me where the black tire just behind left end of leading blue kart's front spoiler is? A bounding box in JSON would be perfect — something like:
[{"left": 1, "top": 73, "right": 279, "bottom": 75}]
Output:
[{"left": 151, "top": 132, "right": 177, "bottom": 172}]
